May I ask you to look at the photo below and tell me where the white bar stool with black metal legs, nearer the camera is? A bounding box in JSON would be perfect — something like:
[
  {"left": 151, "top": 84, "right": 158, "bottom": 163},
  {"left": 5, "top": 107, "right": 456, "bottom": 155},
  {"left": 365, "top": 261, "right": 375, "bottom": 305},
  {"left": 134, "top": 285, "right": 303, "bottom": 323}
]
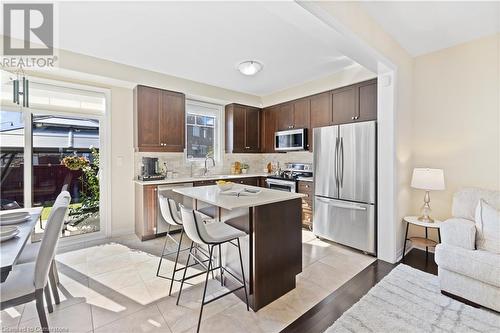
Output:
[{"left": 176, "top": 205, "right": 250, "bottom": 332}]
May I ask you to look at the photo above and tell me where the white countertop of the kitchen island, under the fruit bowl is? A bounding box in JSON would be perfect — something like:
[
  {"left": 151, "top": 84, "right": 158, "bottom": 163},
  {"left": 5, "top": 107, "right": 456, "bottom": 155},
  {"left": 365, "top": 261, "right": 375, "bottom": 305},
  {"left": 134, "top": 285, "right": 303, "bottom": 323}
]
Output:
[{"left": 174, "top": 184, "right": 305, "bottom": 210}]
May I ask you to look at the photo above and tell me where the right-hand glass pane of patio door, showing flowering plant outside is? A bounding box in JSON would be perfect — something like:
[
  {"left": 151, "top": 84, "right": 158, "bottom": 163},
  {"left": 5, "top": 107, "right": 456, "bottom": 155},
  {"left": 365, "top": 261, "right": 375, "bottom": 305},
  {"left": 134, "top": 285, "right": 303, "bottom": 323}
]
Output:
[{"left": 31, "top": 113, "right": 100, "bottom": 237}]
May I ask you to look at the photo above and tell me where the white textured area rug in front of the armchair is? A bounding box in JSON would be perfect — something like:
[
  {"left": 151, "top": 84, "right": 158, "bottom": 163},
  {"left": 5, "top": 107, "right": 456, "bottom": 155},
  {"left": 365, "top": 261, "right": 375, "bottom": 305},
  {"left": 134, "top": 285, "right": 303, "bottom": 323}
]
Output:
[{"left": 326, "top": 264, "right": 500, "bottom": 333}]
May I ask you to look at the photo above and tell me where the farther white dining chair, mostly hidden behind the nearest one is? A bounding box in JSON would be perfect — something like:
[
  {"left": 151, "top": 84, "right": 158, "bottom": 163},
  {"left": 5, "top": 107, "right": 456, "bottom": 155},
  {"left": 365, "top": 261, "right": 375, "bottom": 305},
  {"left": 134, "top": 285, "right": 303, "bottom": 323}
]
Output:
[{"left": 16, "top": 191, "right": 72, "bottom": 304}]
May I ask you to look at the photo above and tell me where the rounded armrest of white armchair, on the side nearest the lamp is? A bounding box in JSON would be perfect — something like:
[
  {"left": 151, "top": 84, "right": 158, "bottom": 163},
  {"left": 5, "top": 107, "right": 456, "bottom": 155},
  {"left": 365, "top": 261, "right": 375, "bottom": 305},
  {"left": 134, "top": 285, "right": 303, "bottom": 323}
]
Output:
[{"left": 440, "top": 217, "right": 476, "bottom": 250}]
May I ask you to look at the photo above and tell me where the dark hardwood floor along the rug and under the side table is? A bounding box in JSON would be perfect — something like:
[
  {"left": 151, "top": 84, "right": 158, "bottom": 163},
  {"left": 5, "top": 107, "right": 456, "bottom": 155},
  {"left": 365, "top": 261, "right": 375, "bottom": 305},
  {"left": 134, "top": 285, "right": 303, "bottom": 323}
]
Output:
[{"left": 281, "top": 249, "right": 437, "bottom": 333}]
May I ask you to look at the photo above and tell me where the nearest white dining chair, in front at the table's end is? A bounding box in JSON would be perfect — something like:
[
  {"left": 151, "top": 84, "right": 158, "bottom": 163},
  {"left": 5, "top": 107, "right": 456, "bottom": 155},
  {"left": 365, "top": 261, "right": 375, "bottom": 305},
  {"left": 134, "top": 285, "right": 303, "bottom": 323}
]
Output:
[{"left": 0, "top": 191, "right": 71, "bottom": 333}]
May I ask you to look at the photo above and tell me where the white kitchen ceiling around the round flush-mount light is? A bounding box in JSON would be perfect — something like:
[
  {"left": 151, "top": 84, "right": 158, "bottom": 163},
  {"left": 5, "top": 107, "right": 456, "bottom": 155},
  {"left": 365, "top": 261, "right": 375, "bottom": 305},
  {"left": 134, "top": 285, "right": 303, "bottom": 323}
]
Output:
[{"left": 59, "top": 2, "right": 356, "bottom": 96}]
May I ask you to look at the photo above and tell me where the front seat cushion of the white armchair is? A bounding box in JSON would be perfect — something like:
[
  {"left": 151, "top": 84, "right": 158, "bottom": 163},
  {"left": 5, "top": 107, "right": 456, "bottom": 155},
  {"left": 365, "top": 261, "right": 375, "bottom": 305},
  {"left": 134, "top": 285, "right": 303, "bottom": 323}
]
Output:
[{"left": 435, "top": 244, "right": 500, "bottom": 288}]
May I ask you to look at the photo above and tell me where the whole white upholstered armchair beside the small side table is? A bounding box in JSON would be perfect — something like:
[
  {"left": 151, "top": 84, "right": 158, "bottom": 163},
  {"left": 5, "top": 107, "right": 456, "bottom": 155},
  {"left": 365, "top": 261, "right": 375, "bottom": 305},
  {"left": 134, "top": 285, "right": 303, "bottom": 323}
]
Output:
[{"left": 435, "top": 188, "right": 500, "bottom": 311}]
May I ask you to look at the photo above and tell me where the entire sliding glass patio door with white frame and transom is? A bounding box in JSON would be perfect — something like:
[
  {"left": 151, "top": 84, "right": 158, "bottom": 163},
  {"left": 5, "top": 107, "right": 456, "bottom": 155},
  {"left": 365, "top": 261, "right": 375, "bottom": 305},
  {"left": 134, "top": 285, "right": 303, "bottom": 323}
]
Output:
[{"left": 0, "top": 72, "right": 107, "bottom": 240}]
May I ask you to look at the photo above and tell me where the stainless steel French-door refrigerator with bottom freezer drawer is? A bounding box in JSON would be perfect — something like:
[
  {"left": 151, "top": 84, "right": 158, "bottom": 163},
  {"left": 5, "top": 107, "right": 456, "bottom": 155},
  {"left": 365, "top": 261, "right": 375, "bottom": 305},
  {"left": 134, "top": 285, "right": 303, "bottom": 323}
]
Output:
[{"left": 313, "top": 121, "right": 377, "bottom": 254}]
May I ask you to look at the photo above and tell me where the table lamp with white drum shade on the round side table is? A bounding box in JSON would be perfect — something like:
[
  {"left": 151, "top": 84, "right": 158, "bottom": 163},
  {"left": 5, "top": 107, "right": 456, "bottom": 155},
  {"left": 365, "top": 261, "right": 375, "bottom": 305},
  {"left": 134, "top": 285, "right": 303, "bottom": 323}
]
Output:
[{"left": 411, "top": 168, "right": 444, "bottom": 222}]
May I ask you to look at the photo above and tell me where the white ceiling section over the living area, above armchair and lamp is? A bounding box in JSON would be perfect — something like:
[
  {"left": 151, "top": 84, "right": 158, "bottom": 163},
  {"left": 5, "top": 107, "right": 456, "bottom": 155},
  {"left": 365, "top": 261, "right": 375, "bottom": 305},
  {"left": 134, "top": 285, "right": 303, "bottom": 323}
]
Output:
[{"left": 362, "top": 1, "right": 500, "bottom": 56}]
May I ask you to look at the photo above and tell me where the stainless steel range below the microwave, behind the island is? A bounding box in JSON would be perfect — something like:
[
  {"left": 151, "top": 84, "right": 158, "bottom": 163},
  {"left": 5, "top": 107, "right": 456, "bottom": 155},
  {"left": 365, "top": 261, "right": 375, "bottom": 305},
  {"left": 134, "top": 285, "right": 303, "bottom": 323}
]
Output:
[{"left": 266, "top": 163, "right": 313, "bottom": 192}]
